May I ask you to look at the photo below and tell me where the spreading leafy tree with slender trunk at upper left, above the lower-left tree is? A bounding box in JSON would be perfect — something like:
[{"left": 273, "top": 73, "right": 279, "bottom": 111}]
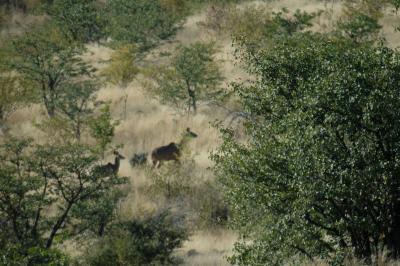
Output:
[{"left": 6, "top": 24, "right": 94, "bottom": 117}]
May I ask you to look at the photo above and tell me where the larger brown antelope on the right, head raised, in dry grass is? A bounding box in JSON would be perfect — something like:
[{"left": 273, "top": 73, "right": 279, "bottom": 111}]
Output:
[{"left": 151, "top": 128, "right": 197, "bottom": 167}]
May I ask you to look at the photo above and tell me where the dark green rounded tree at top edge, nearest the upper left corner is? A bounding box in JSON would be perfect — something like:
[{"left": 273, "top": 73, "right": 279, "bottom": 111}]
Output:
[{"left": 45, "top": 0, "right": 105, "bottom": 42}]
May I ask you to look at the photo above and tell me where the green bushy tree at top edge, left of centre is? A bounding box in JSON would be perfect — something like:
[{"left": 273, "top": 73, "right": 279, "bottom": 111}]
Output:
[{"left": 103, "top": 0, "right": 182, "bottom": 51}]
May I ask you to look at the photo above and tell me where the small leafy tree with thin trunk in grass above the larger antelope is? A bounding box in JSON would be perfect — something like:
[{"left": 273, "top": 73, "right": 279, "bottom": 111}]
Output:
[{"left": 146, "top": 43, "right": 222, "bottom": 113}]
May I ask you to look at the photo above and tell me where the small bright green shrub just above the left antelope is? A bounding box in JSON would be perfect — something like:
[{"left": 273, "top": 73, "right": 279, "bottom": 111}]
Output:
[{"left": 89, "top": 104, "right": 119, "bottom": 154}]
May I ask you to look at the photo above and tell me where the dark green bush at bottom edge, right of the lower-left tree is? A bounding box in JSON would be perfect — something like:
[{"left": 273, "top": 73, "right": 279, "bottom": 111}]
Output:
[{"left": 82, "top": 211, "right": 187, "bottom": 266}]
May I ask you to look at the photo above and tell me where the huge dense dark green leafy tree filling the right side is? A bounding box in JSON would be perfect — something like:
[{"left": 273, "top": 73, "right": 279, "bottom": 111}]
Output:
[{"left": 214, "top": 34, "right": 400, "bottom": 265}]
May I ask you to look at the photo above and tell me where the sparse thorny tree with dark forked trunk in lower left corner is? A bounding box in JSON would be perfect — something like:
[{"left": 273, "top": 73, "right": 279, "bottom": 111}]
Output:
[{"left": 0, "top": 139, "right": 125, "bottom": 255}]
